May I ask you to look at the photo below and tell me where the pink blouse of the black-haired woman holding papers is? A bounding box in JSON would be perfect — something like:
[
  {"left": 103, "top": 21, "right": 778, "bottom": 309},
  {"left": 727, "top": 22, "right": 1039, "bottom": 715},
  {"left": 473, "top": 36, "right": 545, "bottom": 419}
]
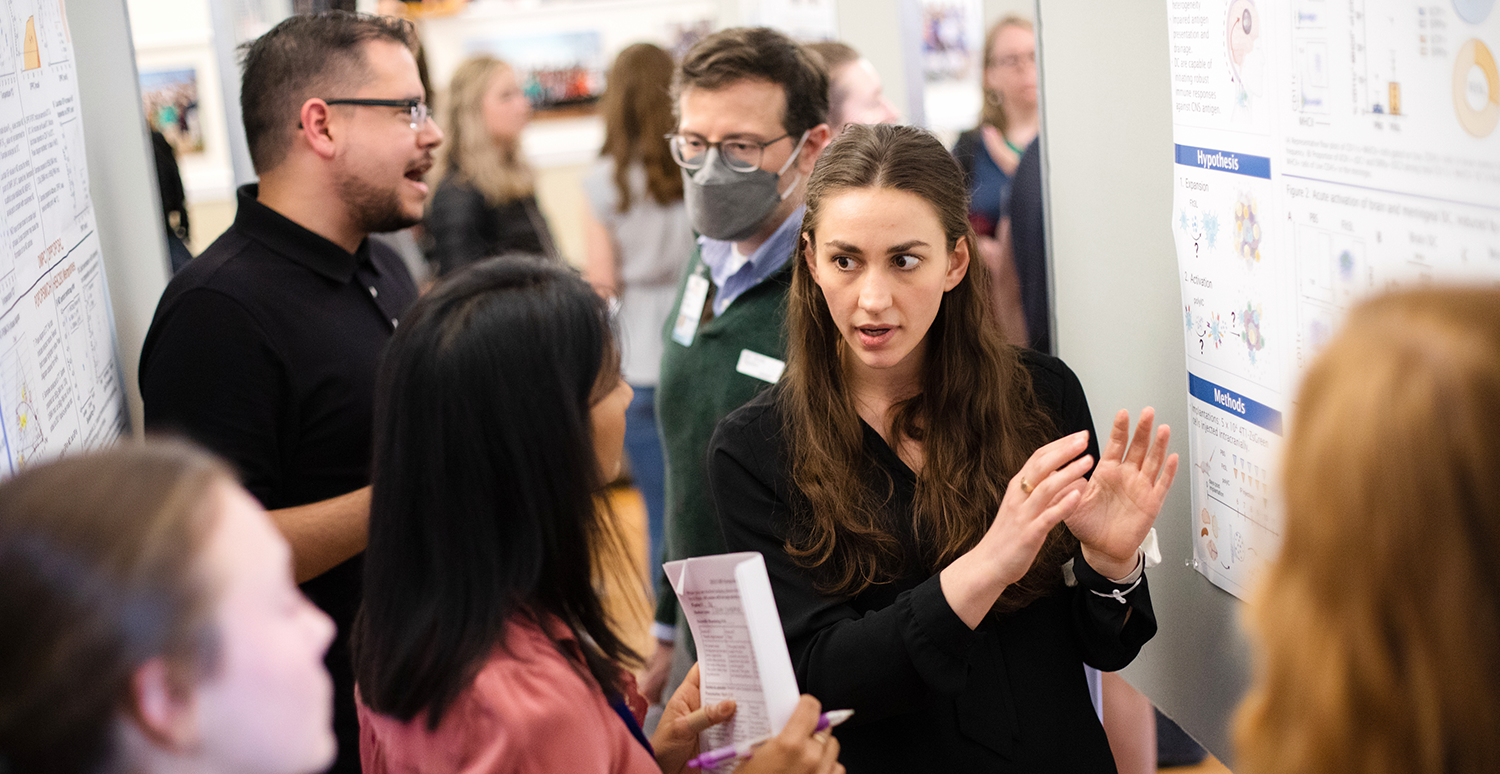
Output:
[{"left": 356, "top": 617, "right": 662, "bottom": 774}]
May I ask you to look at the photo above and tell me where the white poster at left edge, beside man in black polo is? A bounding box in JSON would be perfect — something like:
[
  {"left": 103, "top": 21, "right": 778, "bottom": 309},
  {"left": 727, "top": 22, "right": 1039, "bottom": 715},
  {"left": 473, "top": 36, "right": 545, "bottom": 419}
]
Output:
[{"left": 0, "top": 0, "right": 129, "bottom": 477}]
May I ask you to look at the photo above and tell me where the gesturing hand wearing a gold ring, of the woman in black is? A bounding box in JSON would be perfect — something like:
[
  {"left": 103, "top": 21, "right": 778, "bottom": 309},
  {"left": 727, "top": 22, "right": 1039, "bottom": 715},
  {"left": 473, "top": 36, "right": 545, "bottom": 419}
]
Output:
[{"left": 941, "top": 431, "right": 1094, "bottom": 629}]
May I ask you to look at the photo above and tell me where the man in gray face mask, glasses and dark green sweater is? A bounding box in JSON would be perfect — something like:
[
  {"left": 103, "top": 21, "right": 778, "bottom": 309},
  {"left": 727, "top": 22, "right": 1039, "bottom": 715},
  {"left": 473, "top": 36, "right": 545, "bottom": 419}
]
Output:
[{"left": 642, "top": 27, "right": 831, "bottom": 704}]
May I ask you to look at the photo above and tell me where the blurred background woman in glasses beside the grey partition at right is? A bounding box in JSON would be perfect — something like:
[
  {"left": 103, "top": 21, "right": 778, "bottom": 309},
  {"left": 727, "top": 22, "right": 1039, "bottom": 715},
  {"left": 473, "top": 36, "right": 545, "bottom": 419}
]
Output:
[{"left": 953, "top": 17, "right": 1038, "bottom": 239}]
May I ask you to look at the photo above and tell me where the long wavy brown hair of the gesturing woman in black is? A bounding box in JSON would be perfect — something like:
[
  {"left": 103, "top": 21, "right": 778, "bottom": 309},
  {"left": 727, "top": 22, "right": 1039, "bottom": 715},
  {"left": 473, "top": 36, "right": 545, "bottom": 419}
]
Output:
[{"left": 783, "top": 126, "right": 1077, "bottom": 611}]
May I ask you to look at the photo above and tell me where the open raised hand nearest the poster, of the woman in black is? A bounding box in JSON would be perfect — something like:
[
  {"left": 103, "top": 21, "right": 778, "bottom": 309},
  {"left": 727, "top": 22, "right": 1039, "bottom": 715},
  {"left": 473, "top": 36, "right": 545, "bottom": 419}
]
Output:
[{"left": 1065, "top": 407, "right": 1178, "bottom": 578}]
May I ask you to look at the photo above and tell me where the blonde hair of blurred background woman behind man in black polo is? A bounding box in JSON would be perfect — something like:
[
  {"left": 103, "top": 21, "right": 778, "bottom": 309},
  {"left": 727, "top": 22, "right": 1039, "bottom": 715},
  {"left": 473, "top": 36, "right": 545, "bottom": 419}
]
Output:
[{"left": 432, "top": 54, "right": 536, "bottom": 207}]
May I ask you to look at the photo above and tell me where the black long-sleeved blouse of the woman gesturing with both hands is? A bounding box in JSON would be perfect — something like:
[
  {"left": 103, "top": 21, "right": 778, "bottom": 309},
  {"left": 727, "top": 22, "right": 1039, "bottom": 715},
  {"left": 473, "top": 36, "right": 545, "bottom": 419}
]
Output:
[{"left": 708, "top": 351, "right": 1157, "bottom": 774}]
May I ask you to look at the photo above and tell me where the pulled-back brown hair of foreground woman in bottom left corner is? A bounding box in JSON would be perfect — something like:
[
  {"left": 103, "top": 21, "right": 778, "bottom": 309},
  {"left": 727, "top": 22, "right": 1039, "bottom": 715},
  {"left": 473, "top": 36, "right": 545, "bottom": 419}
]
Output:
[{"left": 0, "top": 443, "right": 234, "bottom": 774}]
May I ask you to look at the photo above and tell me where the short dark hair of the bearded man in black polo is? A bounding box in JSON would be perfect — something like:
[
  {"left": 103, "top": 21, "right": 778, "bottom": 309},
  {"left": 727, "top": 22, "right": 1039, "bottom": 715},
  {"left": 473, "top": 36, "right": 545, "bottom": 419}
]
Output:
[{"left": 240, "top": 11, "right": 417, "bottom": 174}]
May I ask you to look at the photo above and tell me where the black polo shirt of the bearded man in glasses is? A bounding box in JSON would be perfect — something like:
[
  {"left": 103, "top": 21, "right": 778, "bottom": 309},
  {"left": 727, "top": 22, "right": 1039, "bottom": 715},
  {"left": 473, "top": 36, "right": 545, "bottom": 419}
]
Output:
[{"left": 141, "top": 186, "right": 417, "bottom": 771}]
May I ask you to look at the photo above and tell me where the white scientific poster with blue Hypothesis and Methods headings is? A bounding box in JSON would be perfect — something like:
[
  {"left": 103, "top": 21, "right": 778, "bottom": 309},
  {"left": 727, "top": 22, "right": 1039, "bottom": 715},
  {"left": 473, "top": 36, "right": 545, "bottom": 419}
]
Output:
[{"left": 1167, "top": 0, "right": 1500, "bottom": 597}]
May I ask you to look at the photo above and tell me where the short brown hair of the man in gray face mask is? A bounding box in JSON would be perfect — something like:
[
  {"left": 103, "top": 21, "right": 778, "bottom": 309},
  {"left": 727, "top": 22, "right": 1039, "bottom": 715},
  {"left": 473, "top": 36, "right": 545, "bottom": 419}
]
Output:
[{"left": 672, "top": 27, "right": 828, "bottom": 137}]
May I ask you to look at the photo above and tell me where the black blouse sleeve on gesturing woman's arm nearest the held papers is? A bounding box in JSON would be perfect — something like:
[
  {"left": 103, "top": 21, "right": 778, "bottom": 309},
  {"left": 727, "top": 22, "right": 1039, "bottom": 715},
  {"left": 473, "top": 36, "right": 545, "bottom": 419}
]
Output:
[{"left": 708, "top": 407, "right": 975, "bottom": 725}]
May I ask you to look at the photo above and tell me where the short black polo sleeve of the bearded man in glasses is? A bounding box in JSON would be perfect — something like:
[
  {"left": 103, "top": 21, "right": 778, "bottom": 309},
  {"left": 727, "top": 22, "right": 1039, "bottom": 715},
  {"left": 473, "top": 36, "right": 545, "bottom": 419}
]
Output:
[{"left": 141, "top": 288, "right": 290, "bottom": 504}]
